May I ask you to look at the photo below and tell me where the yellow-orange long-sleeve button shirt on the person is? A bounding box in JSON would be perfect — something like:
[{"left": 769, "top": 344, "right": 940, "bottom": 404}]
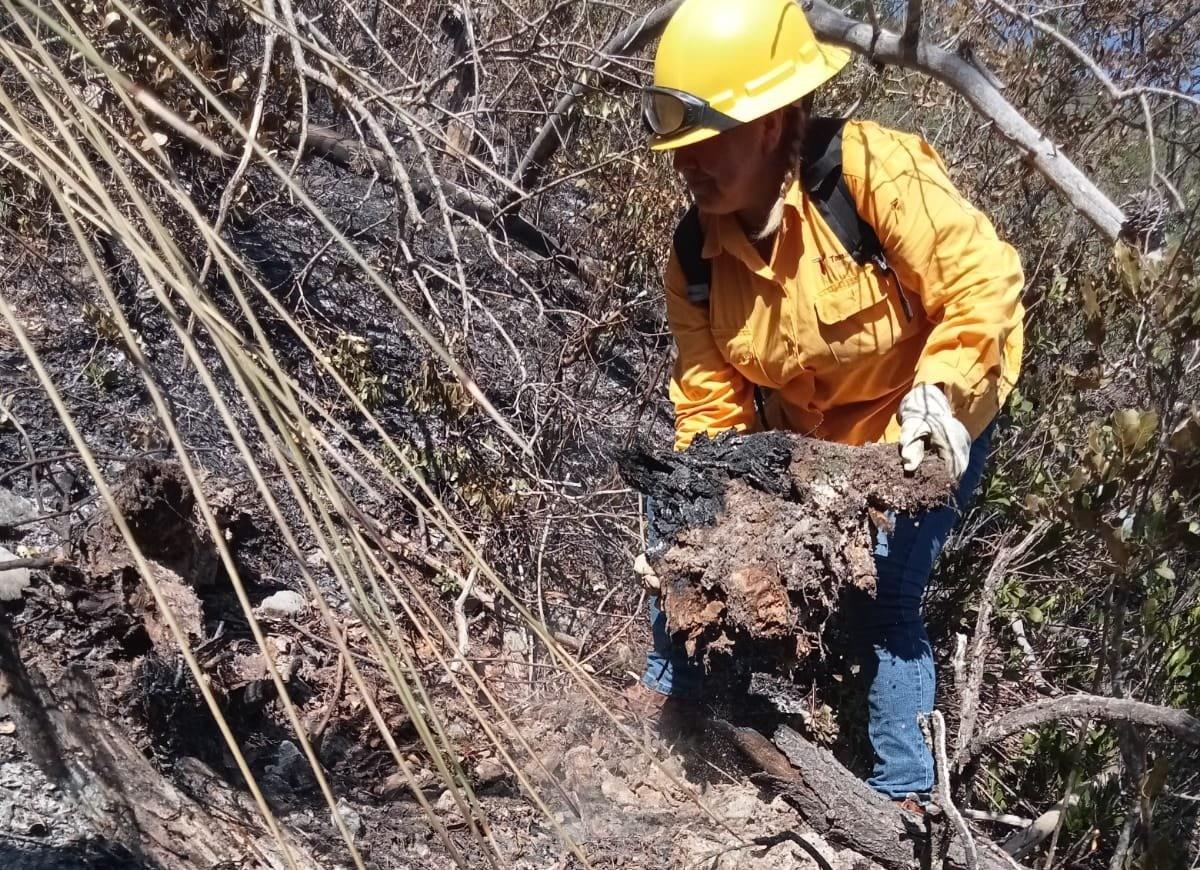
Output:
[{"left": 666, "top": 121, "right": 1024, "bottom": 450}]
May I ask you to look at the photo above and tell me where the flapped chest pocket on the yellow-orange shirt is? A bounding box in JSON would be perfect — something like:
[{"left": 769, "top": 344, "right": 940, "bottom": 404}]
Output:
[{"left": 812, "top": 265, "right": 914, "bottom": 364}]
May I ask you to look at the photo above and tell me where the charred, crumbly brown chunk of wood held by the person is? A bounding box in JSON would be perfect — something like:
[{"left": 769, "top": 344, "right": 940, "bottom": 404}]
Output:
[{"left": 620, "top": 432, "right": 952, "bottom": 661}]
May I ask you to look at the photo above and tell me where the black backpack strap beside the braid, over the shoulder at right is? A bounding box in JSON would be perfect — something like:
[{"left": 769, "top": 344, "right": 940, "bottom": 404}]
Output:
[{"left": 802, "top": 118, "right": 887, "bottom": 269}]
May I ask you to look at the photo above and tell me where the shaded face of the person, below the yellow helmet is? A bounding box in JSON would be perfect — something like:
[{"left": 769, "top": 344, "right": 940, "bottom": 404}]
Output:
[{"left": 673, "top": 113, "right": 782, "bottom": 215}]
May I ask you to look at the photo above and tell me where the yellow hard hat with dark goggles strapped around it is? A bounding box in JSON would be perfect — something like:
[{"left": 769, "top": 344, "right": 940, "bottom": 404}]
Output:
[{"left": 642, "top": 0, "right": 850, "bottom": 151}]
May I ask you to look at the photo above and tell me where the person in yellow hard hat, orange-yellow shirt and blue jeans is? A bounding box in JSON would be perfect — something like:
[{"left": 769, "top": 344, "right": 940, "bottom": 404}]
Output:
[{"left": 630, "top": 0, "right": 1024, "bottom": 806}]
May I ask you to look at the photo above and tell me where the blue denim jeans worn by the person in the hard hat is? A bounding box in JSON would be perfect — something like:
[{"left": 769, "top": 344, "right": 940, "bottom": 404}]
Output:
[{"left": 642, "top": 426, "right": 992, "bottom": 799}]
